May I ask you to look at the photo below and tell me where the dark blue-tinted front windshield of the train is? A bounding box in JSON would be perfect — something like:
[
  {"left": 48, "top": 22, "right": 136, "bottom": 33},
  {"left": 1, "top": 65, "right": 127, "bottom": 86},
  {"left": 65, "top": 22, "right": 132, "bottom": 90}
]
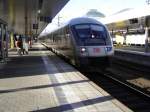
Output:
[{"left": 74, "top": 24, "right": 111, "bottom": 46}]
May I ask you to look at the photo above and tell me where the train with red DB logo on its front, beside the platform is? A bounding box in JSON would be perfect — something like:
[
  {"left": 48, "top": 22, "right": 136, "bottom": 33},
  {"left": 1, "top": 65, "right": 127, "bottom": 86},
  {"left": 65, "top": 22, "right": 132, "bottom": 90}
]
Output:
[{"left": 38, "top": 17, "right": 114, "bottom": 68}]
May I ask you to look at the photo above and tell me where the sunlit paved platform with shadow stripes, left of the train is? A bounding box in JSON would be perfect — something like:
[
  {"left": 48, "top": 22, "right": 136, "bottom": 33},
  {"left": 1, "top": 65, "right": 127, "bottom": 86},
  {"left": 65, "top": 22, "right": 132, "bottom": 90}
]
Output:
[{"left": 0, "top": 43, "right": 131, "bottom": 112}]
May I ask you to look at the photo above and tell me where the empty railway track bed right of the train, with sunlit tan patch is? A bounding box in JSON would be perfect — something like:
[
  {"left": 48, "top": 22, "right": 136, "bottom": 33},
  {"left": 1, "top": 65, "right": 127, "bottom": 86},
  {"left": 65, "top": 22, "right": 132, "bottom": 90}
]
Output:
[{"left": 109, "top": 59, "right": 150, "bottom": 95}]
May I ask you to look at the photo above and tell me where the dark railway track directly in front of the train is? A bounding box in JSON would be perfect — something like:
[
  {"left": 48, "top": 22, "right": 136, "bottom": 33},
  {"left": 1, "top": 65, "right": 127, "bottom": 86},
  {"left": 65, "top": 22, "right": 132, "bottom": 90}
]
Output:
[{"left": 84, "top": 72, "right": 150, "bottom": 112}]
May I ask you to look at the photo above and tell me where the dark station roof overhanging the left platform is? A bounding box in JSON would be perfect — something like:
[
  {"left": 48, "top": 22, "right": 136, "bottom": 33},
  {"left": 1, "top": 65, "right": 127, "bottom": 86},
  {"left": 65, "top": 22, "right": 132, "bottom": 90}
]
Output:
[{"left": 0, "top": 0, "right": 69, "bottom": 34}]
